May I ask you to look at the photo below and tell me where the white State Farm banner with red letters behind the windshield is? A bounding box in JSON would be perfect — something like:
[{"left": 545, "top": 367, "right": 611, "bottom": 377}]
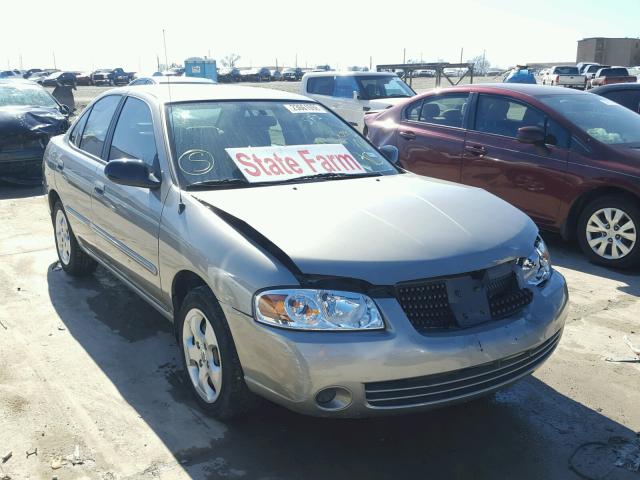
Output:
[{"left": 226, "top": 144, "right": 366, "bottom": 183}]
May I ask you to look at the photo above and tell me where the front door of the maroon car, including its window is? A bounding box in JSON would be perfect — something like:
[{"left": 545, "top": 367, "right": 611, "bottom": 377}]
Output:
[{"left": 462, "top": 94, "right": 571, "bottom": 226}]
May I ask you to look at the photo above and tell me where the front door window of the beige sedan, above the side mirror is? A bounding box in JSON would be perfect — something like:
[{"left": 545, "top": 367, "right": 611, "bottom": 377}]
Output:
[{"left": 109, "top": 97, "right": 157, "bottom": 167}]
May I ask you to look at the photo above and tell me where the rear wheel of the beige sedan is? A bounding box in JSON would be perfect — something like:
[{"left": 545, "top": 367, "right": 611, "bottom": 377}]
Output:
[{"left": 52, "top": 202, "right": 96, "bottom": 277}]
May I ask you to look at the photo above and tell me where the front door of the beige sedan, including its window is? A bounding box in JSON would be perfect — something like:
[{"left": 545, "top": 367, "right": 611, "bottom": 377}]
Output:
[{"left": 92, "top": 97, "right": 167, "bottom": 299}]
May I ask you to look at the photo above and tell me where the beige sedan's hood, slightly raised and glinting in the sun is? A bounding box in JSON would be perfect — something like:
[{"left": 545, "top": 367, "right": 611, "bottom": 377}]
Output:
[{"left": 191, "top": 174, "right": 538, "bottom": 285}]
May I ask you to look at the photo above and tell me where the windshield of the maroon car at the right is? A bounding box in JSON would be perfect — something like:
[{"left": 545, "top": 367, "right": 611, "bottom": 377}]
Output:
[{"left": 539, "top": 93, "right": 640, "bottom": 145}]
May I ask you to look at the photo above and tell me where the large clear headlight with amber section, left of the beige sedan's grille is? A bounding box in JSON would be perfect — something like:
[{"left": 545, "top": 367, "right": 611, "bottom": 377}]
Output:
[{"left": 254, "top": 289, "right": 384, "bottom": 330}]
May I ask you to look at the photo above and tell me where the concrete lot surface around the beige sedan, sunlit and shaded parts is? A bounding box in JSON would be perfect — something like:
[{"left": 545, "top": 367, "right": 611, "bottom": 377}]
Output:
[{"left": 0, "top": 186, "right": 640, "bottom": 480}]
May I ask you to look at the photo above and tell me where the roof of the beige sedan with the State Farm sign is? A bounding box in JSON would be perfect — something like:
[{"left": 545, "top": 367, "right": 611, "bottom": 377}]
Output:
[{"left": 99, "top": 83, "right": 313, "bottom": 104}]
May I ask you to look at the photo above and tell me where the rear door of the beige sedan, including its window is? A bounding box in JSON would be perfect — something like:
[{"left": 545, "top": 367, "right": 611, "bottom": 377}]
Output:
[{"left": 53, "top": 95, "right": 122, "bottom": 245}]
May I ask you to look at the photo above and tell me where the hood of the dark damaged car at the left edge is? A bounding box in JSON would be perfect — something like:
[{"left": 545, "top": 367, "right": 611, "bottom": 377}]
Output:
[{"left": 0, "top": 106, "right": 67, "bottom": 144}]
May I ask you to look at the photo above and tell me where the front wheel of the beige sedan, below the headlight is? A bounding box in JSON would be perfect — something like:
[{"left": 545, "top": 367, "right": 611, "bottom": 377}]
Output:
[{"left": 176, "top": 286, "right": 253, "bottom": 420}]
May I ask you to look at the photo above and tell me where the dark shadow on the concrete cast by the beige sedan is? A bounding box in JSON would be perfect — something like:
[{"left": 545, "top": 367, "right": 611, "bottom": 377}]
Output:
[{"left": 48, "top": 263, "right": 637, "bottom": 480}]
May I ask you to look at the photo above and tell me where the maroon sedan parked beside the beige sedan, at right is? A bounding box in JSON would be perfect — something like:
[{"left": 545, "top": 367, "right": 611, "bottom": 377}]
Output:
[{"left": 365, "top": 84, "right": 640, "bottom": 268}]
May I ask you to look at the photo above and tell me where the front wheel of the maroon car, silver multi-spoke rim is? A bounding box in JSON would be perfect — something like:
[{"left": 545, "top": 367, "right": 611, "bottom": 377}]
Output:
[{"left": 577, "top": 195, "right": 640, "bottom": 268}]
